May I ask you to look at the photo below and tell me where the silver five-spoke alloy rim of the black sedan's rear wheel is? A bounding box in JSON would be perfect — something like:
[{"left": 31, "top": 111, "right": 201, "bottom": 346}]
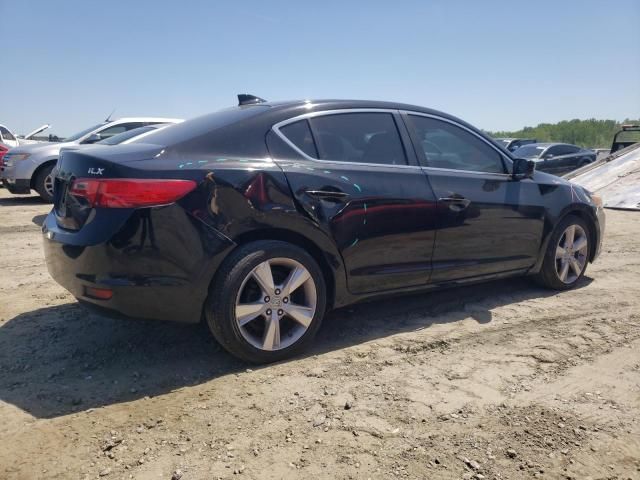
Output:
[{"left": 235, "top": 258, "right": 317, "bottom": 351}]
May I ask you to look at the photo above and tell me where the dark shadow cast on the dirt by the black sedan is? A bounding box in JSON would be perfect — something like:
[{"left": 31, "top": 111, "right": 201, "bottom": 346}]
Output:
[{"left": 0, "top": 278, "right": 591, "bottom": 418}]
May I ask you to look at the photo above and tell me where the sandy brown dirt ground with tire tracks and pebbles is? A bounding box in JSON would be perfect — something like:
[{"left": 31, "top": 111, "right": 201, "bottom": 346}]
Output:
[{"left": 0, "top": 189, "right": 640, "bottom": 480}]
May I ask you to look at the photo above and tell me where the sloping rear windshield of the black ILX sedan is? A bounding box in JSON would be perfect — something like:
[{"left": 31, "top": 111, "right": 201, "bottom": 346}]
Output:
[{"left": 131, "top": 105, "right": 269, "bottom": 146}]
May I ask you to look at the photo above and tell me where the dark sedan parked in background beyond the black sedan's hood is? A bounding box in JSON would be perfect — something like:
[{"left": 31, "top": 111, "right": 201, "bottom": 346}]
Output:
[{"left": 513, "top": 143, "right": 596, "bottom": 175}]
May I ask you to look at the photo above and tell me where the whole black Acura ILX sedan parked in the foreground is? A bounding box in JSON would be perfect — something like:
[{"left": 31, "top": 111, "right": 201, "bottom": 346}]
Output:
[{"left": 43, "top": 96, "right": 604, "bottom": 362}]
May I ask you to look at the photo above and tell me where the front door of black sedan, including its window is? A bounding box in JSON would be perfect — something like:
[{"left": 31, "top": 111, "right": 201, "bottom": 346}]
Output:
[{"left": 403, "top": 112, "right": 544, "bottom": 283}]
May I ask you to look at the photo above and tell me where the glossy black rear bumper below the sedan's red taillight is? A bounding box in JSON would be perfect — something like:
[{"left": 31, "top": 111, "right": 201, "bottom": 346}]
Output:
[{"left": 42, "top": 206, "right": 238, "bottom": 323}]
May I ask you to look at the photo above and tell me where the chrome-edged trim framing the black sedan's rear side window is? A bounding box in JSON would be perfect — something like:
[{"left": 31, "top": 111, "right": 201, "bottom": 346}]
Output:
[{"left": 271, "top": 108, "right": 422, "bottom": 169}]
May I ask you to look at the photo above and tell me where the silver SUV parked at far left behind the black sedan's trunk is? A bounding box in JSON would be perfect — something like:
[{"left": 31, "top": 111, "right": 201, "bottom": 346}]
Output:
[{"left": 0, "top": 117, "right": 182, "bottom": 202}]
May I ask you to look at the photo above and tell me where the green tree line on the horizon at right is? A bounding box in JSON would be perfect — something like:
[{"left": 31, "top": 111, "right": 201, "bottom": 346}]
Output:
[{"left": 488, "top": 118, "right": 640, "bottom": 148}]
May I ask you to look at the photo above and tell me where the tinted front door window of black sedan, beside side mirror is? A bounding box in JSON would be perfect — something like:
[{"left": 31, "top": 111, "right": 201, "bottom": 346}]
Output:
[{"left": 409, "top": 115, "right": 504, "bottom": 173}]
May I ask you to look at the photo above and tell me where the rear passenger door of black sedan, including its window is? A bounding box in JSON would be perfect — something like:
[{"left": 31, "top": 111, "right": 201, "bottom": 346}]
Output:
[{"left": 268, "top": 109, "right": 437, "bottom": 294}]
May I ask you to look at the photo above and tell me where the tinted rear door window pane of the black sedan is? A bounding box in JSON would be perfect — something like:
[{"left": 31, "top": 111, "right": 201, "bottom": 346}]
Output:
[{"left": 309, "top": 113, "right": 407, "bottom": 165}]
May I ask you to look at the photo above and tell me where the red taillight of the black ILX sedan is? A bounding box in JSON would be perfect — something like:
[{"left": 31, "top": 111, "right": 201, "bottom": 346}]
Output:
[{"left": 69, "top": 178, "right": 197, "bottom": 208}]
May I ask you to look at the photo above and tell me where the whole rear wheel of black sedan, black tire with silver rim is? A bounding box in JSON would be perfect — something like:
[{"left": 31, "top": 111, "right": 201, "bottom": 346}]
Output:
[{"left": 205, "top": 240, "right": 327, "bottom": 363}]
